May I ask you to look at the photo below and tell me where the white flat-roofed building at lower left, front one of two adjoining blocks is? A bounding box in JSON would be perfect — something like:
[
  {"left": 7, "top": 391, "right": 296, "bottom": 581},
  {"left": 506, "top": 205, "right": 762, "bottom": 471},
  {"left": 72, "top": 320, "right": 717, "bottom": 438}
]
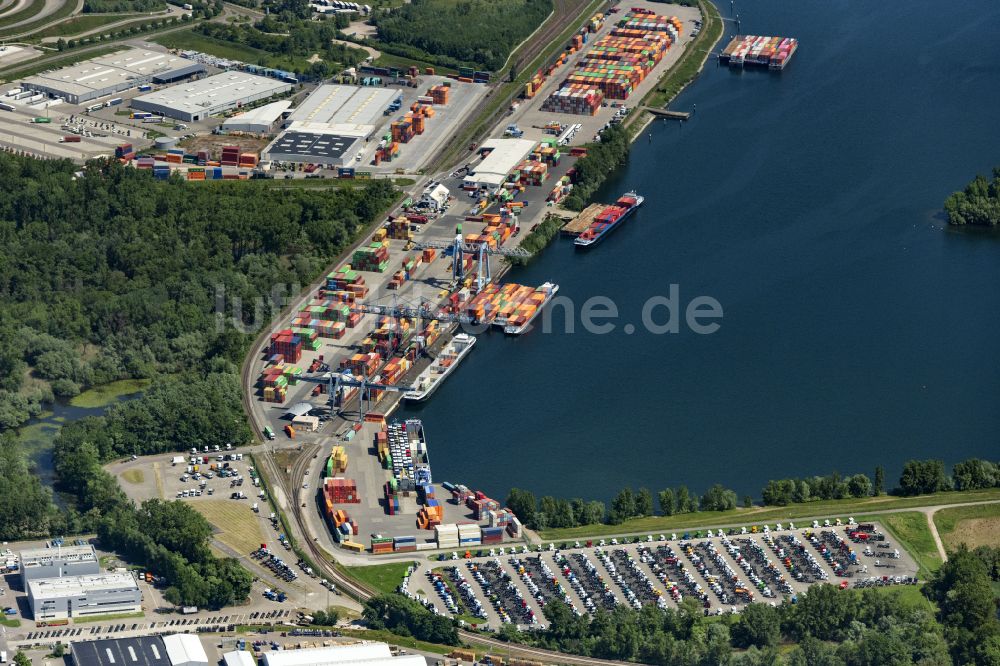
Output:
[{"left": 28, "top": 573, "right": 142, "bottom": 622}]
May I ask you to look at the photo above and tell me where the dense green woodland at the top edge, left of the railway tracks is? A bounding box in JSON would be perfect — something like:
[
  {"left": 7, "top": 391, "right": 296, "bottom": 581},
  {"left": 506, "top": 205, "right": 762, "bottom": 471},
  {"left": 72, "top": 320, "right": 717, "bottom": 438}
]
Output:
[{"left": 373, "top": 0, "right": 553, "bottom": 71}]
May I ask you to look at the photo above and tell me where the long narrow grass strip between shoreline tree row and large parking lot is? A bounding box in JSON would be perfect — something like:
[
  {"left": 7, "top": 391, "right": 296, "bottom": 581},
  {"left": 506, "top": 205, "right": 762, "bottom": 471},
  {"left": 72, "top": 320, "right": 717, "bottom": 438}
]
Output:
[{"left": 540, "top": 488, "right": 1000, "bottom": 541}]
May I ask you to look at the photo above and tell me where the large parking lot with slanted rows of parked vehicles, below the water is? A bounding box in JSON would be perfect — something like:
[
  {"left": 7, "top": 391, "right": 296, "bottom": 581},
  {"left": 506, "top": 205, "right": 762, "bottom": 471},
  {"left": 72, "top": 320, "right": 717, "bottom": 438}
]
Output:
[{"left": 405, "top": 522, "right": 917, "bottom": 629}]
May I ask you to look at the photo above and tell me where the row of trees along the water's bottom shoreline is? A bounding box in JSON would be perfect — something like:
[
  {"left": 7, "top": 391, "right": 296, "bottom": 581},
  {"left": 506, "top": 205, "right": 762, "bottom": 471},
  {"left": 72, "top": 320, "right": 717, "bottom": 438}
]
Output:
[{"left": 506, "top": 458, "right": 1000, "bottom": 530}]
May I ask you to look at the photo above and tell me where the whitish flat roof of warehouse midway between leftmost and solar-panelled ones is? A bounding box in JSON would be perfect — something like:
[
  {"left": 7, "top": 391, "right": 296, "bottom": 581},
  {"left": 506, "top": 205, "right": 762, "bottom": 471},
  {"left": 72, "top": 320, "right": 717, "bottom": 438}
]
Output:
[{"left": 134, "top": 73, "right": 291, "bottom": 113}]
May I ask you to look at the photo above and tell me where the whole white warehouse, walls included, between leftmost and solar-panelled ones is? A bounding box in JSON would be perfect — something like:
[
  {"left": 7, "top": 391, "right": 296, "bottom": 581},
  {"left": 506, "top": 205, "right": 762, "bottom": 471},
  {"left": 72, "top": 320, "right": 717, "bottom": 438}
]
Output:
[{"left": 132, "top": 71, "right": 292, "bottom": 122}]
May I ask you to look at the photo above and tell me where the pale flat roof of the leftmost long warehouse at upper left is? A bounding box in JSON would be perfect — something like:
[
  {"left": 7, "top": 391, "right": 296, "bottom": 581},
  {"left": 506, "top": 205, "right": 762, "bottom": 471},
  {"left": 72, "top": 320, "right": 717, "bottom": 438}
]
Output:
[{"left": 24, "top": 48, "right": 190, "bottom": 95}]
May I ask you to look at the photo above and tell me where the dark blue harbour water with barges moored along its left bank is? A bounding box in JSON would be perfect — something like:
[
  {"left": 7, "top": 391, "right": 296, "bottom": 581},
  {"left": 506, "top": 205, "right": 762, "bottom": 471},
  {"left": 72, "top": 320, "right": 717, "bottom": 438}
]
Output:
[{"left": 395, "top": 0, "right": 1000, "bottom": 499}]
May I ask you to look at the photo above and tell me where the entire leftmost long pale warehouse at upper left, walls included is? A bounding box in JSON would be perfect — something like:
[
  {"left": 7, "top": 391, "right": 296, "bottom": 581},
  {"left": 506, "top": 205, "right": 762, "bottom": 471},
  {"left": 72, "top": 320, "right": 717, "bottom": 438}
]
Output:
[{"left": 21, "top": 48, "right": 197, "bottom": 104}]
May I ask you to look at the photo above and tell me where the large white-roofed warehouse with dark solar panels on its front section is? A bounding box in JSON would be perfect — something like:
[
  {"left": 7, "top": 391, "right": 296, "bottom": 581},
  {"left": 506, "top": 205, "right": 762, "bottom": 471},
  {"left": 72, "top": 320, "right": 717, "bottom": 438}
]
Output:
[{"left": 262, "top": 84, "right": 400, "bottom": 167}]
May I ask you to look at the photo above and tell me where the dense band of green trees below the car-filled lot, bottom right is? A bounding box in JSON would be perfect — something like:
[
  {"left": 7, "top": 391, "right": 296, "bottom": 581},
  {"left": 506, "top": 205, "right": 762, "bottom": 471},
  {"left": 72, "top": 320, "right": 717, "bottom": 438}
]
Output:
[{"left": 500, "top": 547, "right": 1000, "bottom": 666}]
